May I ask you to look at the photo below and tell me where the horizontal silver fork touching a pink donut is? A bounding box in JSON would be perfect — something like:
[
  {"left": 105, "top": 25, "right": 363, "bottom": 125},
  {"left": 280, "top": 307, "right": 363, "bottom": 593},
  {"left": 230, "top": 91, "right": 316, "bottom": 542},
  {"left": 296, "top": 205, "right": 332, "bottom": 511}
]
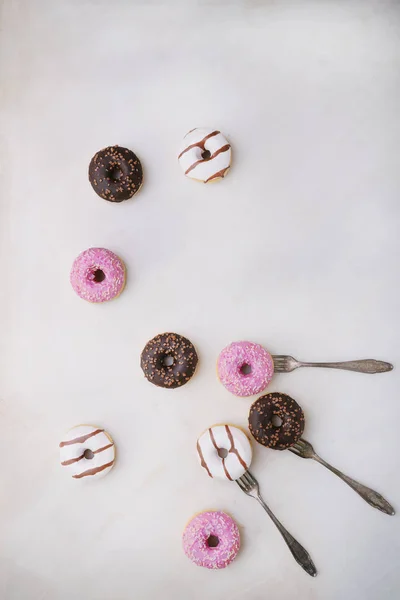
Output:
[{"left": 272, "top": 354, "right": 393, "bottom": 373}]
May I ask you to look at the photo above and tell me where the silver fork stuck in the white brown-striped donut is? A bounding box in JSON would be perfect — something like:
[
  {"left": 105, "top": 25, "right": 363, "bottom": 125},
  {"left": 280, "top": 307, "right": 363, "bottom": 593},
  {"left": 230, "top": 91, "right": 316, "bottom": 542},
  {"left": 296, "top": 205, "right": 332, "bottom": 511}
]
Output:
[{"left": 236, "top": 471, "right": 317, "bottom": 577}]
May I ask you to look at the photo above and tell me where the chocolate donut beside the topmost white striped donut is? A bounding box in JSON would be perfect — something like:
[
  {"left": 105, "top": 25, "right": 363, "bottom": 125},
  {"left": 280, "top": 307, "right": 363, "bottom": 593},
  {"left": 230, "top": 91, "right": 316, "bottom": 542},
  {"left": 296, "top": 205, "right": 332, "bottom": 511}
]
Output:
[{"left": 89, "top": 146, "right": 143, "bottom": 202}]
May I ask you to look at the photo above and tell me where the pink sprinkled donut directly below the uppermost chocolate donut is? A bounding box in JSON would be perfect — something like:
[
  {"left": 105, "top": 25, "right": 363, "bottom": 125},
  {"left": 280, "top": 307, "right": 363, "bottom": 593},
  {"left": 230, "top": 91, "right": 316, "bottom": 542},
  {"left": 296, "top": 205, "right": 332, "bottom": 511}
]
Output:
[{"left": 70, "top": 248, "right": 126, "bottom": 302}]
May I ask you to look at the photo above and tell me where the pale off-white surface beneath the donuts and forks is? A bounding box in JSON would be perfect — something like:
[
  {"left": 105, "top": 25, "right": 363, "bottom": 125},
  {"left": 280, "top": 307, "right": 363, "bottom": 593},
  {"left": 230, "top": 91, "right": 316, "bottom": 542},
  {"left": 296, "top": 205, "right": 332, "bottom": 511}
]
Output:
[{"left": 0, "top": 0, "right": 400, "bottom": 600}]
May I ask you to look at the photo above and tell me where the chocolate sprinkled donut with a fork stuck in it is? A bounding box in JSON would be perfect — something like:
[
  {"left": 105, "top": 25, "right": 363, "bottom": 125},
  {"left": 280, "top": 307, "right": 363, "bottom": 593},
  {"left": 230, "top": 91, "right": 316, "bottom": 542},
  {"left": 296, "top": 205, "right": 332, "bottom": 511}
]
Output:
[{"left": 249, "top": 392, "right": 304, "bottom": 450}]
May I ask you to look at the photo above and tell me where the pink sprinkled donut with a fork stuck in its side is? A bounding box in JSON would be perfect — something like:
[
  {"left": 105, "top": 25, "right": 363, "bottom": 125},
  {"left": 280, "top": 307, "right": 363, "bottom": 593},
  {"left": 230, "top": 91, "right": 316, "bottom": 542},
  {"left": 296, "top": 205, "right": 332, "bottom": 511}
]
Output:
[{"left": 217, "top": 342, "right": 274, "bottom": 396}]
